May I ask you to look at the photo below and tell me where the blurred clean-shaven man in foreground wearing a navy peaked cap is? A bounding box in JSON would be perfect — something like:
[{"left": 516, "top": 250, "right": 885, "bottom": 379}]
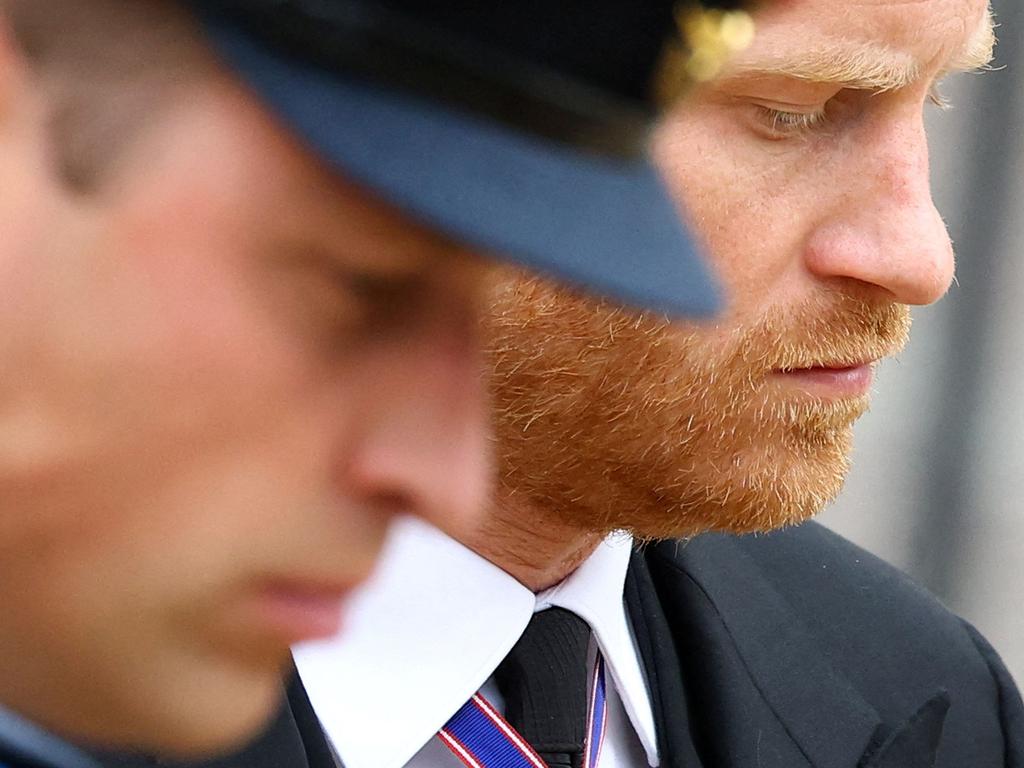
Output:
[{"left": 0, "top": 0, "right": 729, "bottom": 766}]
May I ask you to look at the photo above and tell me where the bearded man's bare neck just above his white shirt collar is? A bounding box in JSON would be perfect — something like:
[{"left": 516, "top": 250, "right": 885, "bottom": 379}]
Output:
[{"left": 448, "top": 499, "right": 604, "bottom": 592}]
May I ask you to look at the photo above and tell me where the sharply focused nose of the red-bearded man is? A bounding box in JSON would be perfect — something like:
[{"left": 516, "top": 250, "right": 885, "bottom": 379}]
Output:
[{"left": 805, "top": 110, "right": 953, "bottom": 304}]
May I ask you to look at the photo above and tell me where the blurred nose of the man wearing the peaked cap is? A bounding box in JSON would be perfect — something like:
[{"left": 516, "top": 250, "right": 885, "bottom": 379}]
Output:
[{"left": 343, "top": 280, "right": 492, "bottom": 534}]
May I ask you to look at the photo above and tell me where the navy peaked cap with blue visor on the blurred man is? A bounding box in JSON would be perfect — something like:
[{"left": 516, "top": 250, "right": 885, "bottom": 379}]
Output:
[{"left": 187, "top": 0, "right": 753, "bottom": 316}]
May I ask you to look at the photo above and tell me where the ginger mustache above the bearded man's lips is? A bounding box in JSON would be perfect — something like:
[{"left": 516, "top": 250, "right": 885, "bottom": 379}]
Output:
[{"left": 736, "top": 294, "right": 910, "bottom": 371}]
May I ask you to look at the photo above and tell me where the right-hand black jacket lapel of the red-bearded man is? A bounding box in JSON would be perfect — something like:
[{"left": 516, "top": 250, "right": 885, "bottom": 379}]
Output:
[{"left": 627, "top": 536, "right": 948, "bottom": 768}]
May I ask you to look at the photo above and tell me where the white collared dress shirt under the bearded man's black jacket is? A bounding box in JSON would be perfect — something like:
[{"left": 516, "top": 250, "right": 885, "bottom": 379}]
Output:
[{"left": 295, "top": 519, "right": 658, "bottom": 768}]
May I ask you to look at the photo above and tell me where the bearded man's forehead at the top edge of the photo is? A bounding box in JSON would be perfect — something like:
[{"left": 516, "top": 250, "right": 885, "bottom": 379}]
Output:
[{"left": 733, "top": 0, "right": 991, "bottom": 74}]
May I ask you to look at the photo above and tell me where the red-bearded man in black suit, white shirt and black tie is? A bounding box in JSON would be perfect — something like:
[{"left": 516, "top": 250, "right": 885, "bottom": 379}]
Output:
[{"left": 296, "top": 0, "right": 1024, "bottom": 768}]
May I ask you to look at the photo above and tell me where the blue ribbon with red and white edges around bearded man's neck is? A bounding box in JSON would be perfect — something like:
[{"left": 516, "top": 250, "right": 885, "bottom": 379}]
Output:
[{"left": 437, "top": 653, "right": 607, "bottom": 768}]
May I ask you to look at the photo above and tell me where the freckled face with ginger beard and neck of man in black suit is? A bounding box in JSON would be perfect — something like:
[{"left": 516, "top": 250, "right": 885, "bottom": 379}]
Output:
[{"left": 468, "top": 0, "right": 987, "bottom": 586}]
